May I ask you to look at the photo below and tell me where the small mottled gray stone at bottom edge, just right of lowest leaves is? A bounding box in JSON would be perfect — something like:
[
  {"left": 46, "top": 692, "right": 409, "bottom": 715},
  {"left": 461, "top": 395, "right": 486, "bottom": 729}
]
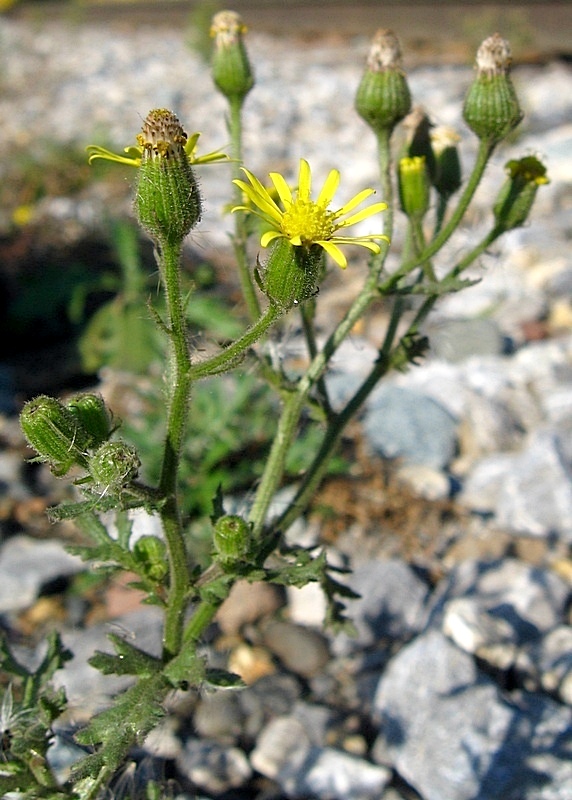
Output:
[{"left": 176, "top": 739, "right": 252, "bottom": 794}]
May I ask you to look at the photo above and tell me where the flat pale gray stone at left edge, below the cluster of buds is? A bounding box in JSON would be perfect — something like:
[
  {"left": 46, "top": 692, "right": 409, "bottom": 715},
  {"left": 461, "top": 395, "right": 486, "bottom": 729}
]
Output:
[{"left": 0, "top": 535, "right": 85, "bottom": 613}]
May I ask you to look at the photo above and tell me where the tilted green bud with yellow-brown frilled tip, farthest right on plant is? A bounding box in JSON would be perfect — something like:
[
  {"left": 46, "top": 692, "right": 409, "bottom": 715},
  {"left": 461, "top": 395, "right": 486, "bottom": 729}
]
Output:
[{"left": 493, "top": 156, "right": 549, "bottom": 233}]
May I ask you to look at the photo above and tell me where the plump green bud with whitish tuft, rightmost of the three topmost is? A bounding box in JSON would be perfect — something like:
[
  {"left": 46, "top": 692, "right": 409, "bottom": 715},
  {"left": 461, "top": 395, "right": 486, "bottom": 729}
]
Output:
[{"left": 463, "top": 33, "right": 523, "bottom": 144}]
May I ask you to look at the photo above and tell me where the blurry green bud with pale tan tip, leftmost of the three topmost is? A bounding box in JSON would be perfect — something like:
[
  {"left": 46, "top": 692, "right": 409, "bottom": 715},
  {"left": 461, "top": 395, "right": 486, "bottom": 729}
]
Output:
[{"left": 211, "top": 11, "right": 254, "bottom": 101}]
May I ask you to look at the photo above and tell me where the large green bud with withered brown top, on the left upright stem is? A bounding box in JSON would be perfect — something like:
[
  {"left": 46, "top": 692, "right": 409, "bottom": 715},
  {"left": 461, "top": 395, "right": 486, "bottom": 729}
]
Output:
[{"left": 135, "top": 108, "right": 201, "bottom": 245}]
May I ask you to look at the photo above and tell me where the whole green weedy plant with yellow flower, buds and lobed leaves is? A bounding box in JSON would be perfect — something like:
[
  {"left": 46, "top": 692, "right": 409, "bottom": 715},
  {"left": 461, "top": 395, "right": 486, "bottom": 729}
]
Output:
[{"left": 5, "top": 11, "right": 547, "bottom": 800}]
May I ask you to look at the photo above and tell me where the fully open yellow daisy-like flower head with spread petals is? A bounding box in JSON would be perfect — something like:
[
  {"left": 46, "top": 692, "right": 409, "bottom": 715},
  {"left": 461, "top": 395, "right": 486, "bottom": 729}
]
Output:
[{"left": 232, "top": 159, "right": 389, "bottom": 269}]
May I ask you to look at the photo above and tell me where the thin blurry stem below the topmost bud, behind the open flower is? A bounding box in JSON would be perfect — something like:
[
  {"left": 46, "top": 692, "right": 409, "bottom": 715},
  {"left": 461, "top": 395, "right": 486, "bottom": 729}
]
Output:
[{"left": 228, "top": 97, "right": 260, "bottom": 320}]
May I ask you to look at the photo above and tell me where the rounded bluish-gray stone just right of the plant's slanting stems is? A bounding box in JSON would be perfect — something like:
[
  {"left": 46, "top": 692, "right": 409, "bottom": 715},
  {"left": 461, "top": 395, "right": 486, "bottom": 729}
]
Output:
[{"left": 363, "top": 384, "right": 457, "bottom": 468}]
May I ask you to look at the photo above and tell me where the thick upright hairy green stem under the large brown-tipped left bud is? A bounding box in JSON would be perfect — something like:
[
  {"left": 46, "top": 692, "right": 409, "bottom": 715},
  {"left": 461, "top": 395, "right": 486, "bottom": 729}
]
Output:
[{"left": 159, "top": 242, "right": 191, "bottom": 659}]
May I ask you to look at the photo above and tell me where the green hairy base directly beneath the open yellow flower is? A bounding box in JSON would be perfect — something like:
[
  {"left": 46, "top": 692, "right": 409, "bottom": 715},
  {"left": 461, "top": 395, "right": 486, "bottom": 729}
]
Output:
[{"left": 257, "top": 239, "right": 324, "bottom": 311}]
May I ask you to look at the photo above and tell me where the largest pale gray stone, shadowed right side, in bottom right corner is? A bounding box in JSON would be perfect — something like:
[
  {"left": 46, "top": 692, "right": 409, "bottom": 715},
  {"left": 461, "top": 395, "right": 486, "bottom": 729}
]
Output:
[{"left": 373, "top": 631, "right": 572, "bottom": 800}]
